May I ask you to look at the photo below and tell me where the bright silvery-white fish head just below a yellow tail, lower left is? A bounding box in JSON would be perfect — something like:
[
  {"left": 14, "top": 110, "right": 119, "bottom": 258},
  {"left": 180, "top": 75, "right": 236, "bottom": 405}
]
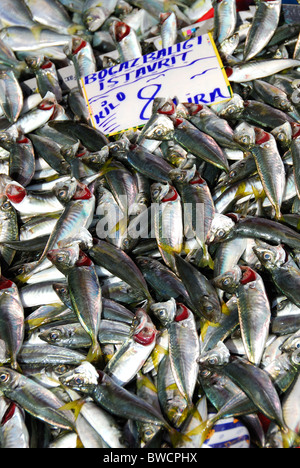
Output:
[{"left": 59, "top": 361, "right": 99, "bottom": 393}]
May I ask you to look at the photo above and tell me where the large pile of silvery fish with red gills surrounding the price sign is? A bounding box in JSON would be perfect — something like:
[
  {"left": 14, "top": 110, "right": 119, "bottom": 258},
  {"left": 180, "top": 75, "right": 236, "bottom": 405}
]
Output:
[{"left": 0, "top": 0, "right": 300, "bottom": 449}]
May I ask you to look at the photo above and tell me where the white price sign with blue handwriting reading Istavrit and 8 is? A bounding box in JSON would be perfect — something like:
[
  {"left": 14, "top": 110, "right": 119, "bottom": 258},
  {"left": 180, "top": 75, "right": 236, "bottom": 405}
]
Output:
[{"left": 82, "top": 34, "right": 232, "bottom": 136}]
